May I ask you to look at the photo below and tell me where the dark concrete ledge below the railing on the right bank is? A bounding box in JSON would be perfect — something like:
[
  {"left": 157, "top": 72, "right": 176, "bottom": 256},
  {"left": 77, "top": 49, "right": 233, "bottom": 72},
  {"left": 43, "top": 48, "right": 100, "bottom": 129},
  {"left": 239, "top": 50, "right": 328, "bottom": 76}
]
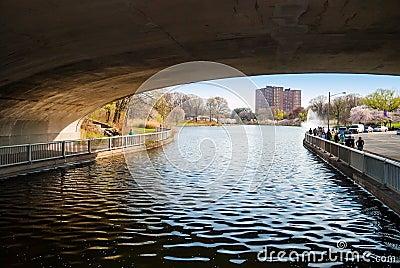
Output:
[{"left": 303, "top": 140, "right": 400, "bottom": 214}]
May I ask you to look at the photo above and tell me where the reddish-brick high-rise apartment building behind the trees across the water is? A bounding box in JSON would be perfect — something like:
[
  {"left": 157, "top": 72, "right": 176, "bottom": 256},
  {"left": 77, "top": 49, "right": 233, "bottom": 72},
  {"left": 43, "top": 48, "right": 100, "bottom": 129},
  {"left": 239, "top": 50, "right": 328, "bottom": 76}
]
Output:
[{"left": 256, "top": 86, "right": 301, "bottom": 113}]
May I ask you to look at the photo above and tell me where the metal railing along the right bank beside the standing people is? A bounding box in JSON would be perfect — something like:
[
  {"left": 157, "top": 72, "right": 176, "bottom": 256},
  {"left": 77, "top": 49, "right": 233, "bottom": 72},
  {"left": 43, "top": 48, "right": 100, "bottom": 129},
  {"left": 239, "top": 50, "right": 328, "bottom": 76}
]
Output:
[{"left": 304, "top": 133, "right": 400, "bottom": 193}]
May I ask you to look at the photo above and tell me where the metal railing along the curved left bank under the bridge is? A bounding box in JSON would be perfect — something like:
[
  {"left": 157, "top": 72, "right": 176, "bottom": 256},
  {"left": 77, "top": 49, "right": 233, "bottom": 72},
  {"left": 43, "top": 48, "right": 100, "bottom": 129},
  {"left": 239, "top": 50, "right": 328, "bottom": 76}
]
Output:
[{"left": 0, "top": 129, "right": 172, "bottom": 168}]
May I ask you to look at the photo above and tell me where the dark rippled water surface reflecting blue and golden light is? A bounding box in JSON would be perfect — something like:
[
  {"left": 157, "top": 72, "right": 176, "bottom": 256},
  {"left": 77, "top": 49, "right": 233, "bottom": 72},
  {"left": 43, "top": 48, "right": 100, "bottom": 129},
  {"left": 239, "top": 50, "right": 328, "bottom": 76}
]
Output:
[{"left": 0, "top": 126, "right": 400, "bottom": 267}]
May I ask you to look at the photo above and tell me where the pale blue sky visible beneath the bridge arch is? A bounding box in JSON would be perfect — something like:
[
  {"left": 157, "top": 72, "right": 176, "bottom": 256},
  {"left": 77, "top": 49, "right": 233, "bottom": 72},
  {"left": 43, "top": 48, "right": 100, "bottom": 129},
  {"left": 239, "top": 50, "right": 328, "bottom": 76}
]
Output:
[{"left": 175, "top": 73, "right": 400, "bottom": 109}]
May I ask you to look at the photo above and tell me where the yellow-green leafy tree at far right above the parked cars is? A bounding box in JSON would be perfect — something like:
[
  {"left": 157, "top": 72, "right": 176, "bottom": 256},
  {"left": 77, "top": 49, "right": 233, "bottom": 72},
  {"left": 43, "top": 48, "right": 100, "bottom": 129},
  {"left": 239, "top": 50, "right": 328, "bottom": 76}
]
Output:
[{"left": 362, "top": 88, "right": 400, "bottom": 112}]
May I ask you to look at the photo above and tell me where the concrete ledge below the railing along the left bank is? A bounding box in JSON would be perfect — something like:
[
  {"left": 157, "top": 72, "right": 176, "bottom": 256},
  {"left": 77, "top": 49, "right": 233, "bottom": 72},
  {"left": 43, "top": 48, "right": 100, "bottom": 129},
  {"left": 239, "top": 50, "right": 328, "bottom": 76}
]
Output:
[{"left": 0, "top": 138, "right": 174, "bottom": 179}]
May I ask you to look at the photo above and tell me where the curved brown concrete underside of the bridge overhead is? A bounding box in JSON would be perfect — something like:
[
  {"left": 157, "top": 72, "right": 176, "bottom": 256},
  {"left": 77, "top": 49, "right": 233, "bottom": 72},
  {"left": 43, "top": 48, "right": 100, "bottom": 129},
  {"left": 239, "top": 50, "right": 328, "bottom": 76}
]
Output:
[{"left": 0, "top": 0, "right": 400, "bottom": 144}]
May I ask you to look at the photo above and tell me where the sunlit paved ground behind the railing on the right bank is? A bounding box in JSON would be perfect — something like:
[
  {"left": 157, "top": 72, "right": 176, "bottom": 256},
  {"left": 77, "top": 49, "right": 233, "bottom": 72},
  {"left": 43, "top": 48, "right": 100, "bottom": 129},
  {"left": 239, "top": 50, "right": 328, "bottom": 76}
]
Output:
[{"left": 355, "top": 131, "right": 400, "bottom": 162}]
